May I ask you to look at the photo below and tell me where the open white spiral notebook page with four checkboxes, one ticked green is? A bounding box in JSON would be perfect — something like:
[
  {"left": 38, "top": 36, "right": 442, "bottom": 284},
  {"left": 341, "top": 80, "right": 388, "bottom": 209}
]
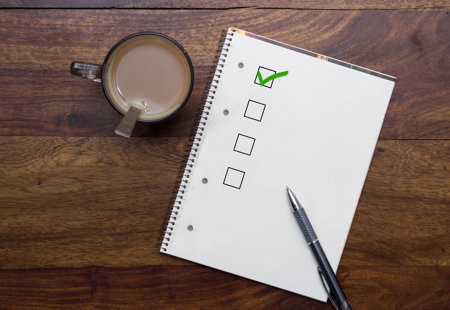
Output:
[{"left": 161, "top": 28, "right": 395, "bottom": 301}]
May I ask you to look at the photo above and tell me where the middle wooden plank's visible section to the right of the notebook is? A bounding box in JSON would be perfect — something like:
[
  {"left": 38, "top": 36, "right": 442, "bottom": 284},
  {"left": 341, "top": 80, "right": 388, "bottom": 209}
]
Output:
[{"left": 343, "top": 141, "right": 450, "bottom": 266}]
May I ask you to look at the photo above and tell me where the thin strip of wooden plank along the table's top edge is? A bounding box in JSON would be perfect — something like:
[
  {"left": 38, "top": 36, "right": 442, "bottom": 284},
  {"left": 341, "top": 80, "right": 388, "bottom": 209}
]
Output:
[{"left": 0, "top": 0, "right": 450, "bottom": 10}]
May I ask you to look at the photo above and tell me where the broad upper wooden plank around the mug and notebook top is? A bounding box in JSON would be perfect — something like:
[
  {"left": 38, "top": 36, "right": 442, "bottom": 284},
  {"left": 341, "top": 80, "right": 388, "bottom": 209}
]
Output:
[{"left": 0, "top": 9, "right": 450, "bottom": 139}]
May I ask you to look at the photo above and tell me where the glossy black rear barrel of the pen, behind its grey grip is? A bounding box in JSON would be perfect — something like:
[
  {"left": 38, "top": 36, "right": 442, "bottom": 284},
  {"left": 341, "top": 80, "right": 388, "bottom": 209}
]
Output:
[{"left": 309, "top": 241, "right": 350, "bottom": 309}]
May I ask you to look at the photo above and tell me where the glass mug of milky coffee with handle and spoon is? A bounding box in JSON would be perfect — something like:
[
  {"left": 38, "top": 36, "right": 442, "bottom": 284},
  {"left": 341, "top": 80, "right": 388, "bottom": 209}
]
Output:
[{"left": 70, "top": 32, "right": 194, "bottom": 138}]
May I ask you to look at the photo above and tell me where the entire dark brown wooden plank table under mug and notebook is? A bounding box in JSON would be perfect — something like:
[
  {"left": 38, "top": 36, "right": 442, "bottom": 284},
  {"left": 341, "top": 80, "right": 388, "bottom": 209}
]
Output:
[{"left": 0, "top": 0, "right": 450, "bottom": 310}]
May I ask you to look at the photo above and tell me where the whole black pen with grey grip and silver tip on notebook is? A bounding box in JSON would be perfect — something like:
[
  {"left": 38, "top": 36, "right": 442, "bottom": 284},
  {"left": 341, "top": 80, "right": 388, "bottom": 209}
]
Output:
[{"left": 286, "top": 186, "right": 351, "bottom": 310}]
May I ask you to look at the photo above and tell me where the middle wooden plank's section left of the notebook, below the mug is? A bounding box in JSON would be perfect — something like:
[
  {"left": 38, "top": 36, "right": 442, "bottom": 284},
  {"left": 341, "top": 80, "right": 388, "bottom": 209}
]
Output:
[{"left": 0, "top": 137, "right": 187, "bottom": 268}]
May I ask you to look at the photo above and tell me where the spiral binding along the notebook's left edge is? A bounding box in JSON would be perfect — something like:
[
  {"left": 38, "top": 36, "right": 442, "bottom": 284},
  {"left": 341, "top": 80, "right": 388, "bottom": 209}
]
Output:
[{"left": 160, "top": 30, "right": 234, "bottom": 252}]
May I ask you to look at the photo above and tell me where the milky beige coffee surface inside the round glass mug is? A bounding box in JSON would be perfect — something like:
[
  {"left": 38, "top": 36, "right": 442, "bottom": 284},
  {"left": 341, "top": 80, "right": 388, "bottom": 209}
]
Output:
[{"left": 103, "top": 36, "right": 190, "bottom": 120}]
